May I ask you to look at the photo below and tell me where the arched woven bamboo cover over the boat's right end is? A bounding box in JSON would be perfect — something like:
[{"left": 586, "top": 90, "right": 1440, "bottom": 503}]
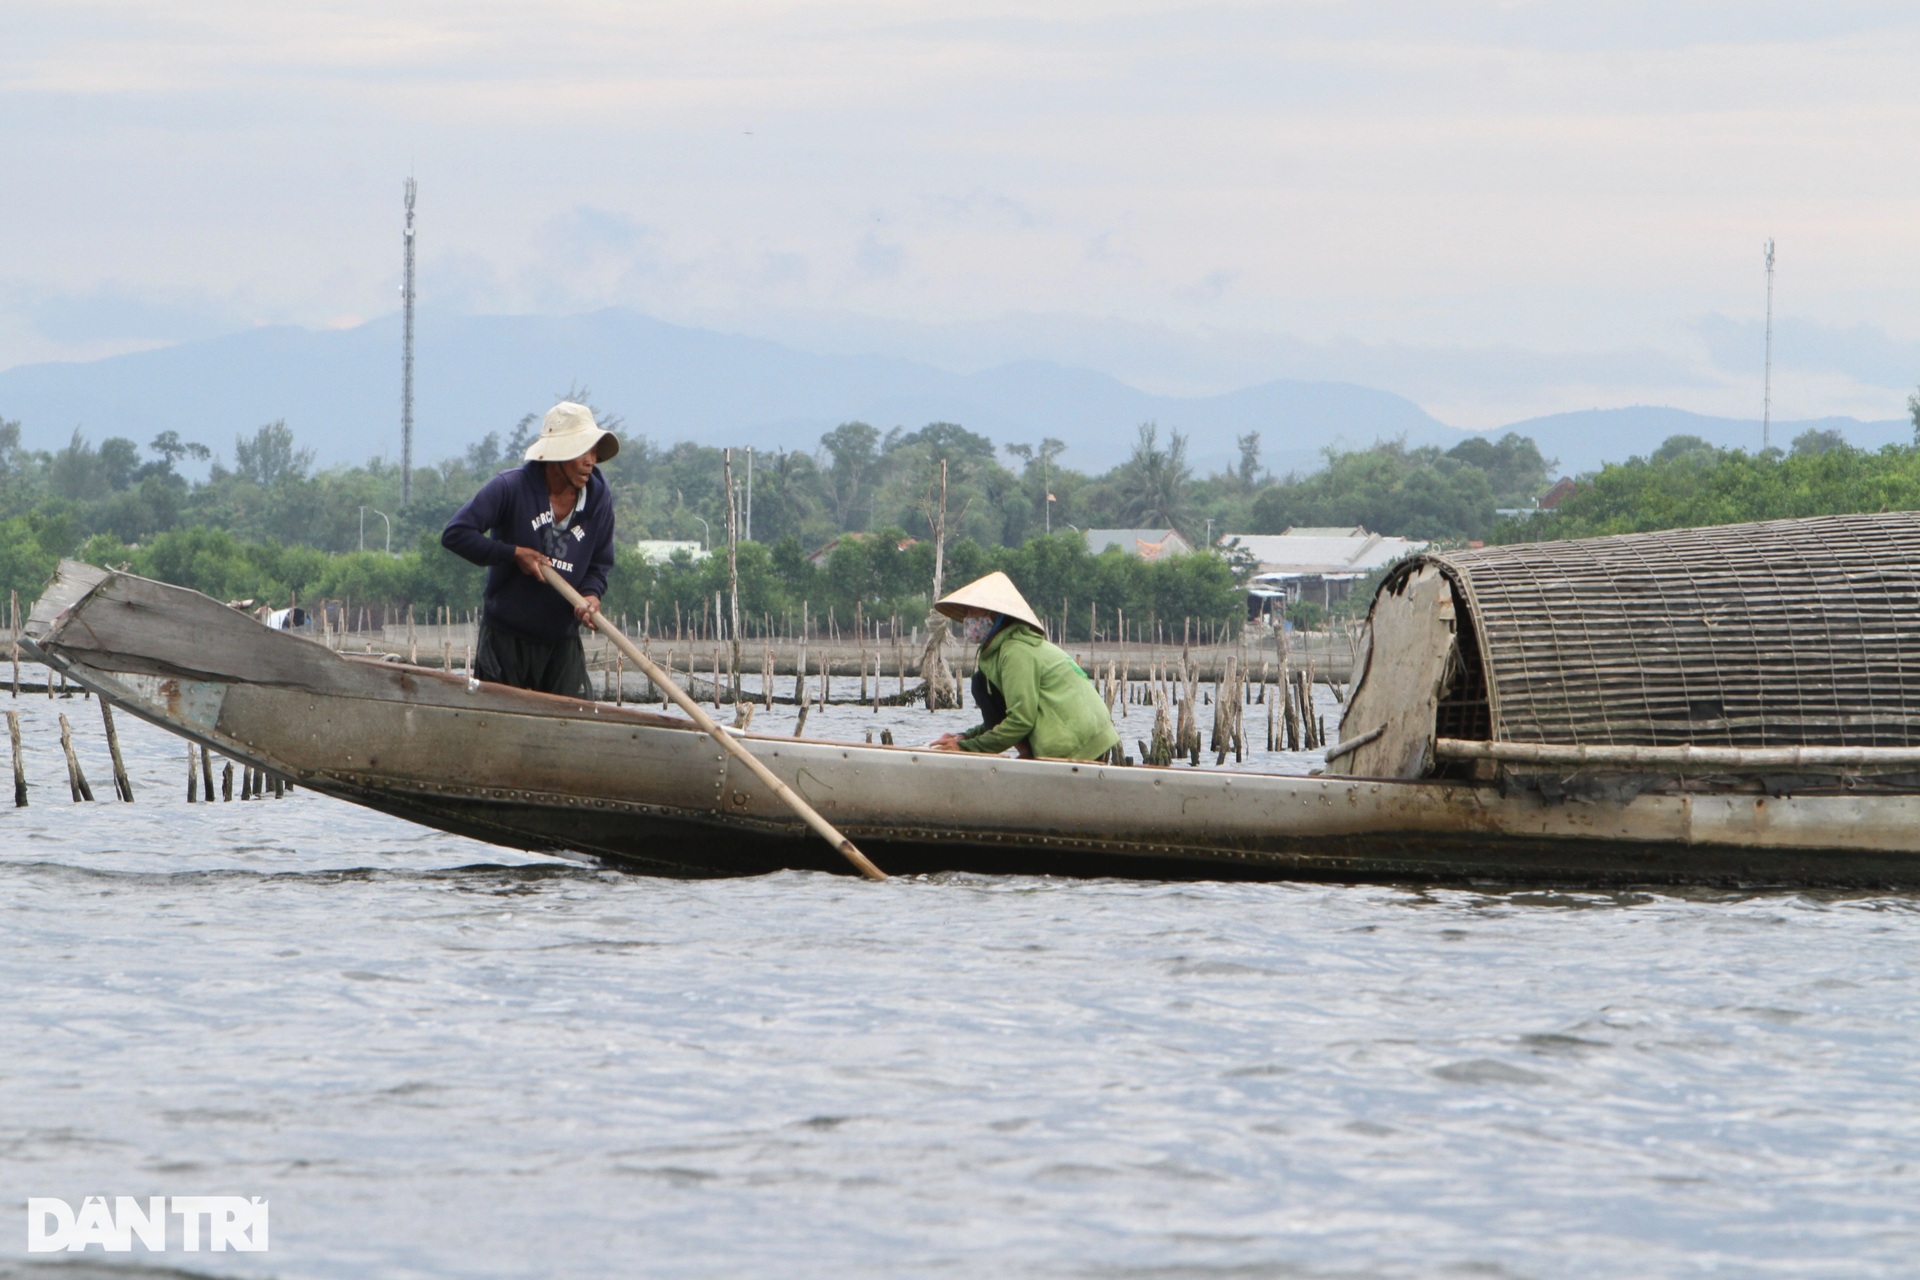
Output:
[{"left": 1425, "top": 512, "right": 1920, "bottom": 747}]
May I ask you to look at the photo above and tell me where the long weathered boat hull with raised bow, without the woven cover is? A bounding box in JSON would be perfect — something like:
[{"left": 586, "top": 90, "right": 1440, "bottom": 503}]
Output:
[{"left": 31, "top": 574, "right": 1920, "bottom": 887}]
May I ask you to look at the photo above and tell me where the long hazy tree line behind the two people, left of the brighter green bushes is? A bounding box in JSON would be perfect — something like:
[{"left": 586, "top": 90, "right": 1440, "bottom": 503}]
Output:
[{"left": 0, "top": 388, "right": 1548, "bottom": 633}]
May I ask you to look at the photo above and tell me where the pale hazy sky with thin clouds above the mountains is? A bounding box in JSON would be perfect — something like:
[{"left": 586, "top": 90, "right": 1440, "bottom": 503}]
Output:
[{"left": 0, "top": 0, "right": 1920, "bottom": 426}]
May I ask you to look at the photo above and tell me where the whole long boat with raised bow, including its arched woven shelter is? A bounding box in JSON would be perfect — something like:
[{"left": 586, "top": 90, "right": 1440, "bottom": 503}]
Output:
[{"left": 27, "top": 516, "right": 1920, "bottom": 887}]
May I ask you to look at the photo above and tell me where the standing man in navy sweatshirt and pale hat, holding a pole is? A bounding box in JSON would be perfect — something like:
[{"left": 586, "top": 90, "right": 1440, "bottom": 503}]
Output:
[{"left": 440, "top": 401, "right": 620, "bottom": 699}]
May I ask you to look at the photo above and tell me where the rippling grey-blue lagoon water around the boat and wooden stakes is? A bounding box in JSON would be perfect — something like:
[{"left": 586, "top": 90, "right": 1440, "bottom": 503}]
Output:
[{"left": 0, "top": 697, "right": 1920, "bottom": 1280}]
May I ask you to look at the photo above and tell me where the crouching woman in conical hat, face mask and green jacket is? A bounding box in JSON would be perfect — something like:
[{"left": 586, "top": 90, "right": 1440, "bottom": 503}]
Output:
[{"left": 931, "top": 574, "right": 1119, "bottom": 760}]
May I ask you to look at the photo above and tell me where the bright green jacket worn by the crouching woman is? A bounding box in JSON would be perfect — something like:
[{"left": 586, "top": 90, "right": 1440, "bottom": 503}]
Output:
[{"left": 960, "top": 622, "right": 1119, "bottom": 760}]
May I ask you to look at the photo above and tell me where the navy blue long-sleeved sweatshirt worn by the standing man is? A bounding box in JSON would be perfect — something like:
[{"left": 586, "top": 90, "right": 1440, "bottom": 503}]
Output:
[{"left": 440, "top": 462, "right": 612, "bottom": 645}]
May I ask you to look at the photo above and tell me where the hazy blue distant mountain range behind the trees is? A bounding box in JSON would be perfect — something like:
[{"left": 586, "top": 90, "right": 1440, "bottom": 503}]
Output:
[{"left": 0, "top": 309, "right": 1912, "bottom": 474}]
